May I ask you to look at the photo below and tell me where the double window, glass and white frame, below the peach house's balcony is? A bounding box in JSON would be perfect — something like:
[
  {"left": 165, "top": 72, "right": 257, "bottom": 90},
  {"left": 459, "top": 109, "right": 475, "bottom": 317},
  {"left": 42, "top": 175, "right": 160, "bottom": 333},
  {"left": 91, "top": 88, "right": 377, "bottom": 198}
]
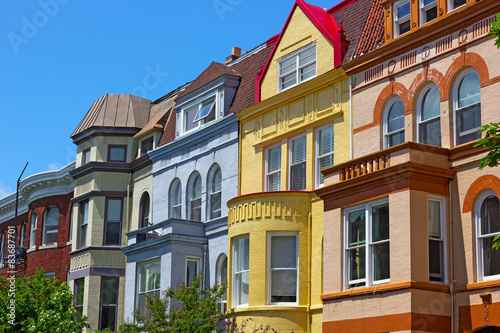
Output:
[{"left": 344, "top": 201, "right": 390, "bottom": 289}]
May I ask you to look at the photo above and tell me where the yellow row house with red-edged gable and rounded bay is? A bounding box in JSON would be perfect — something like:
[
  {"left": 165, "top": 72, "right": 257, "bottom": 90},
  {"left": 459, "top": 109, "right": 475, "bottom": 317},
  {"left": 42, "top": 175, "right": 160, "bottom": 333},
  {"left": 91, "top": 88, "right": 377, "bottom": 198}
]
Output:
[{"left": 227, "top": 0, "right": 371, "bottom": 332}]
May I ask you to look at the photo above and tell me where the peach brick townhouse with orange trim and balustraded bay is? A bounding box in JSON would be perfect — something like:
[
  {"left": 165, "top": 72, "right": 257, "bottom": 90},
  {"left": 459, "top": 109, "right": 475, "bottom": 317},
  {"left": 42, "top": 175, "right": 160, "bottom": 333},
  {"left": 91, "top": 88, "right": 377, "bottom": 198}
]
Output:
[{"left": 315, "top": 0, "right": 500, "bottom": 332}]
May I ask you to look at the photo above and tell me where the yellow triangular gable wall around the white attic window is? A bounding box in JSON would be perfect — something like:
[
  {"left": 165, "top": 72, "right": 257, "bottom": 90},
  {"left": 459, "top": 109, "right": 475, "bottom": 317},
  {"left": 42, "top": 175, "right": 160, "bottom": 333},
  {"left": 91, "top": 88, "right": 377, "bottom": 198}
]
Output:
[{"left": 261, "top": 6, "right": 336, "bottom": 100}]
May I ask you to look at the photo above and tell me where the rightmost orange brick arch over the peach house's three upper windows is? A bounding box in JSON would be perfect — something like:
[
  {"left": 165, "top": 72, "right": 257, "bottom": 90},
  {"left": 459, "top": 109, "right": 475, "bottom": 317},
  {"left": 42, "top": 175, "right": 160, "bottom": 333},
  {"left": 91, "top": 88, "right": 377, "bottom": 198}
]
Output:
[{"left": 445, "top": 51, "right": 490, "bottom": 93}]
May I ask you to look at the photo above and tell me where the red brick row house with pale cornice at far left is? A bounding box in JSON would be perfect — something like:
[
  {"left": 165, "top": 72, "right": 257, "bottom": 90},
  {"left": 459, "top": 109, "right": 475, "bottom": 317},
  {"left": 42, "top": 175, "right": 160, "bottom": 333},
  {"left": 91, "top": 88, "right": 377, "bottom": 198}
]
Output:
[{"left": 0, "top": 162, "right": 75, "bottom": 281}]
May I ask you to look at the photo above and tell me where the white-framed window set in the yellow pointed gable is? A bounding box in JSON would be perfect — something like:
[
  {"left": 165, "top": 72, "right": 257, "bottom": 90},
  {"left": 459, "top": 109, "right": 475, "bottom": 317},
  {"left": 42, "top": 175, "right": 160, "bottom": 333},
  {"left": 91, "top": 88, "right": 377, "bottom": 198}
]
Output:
[{"left": 278, "top": 44, "right": 316, "bottom": 91}]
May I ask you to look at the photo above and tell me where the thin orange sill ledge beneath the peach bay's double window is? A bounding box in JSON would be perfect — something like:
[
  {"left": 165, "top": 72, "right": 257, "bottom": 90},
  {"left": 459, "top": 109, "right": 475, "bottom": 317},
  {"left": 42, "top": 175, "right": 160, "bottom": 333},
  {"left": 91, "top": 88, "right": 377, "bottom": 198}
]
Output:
[{"left": 321, "top": 281, "right": 450, "bottom": 301}]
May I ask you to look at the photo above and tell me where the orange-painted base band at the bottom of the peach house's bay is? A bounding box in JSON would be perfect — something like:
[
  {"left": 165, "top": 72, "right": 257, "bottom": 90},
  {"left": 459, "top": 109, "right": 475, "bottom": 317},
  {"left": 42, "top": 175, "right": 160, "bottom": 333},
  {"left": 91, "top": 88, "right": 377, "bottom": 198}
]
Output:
[{"left": 323, "top": 312, "right": 451, "bottom": 333}]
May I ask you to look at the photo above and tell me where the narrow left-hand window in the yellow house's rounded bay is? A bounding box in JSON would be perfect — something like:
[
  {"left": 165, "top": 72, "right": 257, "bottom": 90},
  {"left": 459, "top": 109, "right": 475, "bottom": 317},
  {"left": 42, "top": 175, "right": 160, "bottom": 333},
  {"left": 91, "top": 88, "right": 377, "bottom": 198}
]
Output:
[{"left": 233, "top": 236, "right": 250, "bottom": 307}]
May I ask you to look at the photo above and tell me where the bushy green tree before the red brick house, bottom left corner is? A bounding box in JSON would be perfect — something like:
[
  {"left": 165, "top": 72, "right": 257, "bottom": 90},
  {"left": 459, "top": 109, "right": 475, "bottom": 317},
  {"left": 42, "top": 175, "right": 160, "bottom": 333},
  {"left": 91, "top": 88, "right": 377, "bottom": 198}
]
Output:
[{"left": 0, "top": 270, "right": 89, "bottom": 333}]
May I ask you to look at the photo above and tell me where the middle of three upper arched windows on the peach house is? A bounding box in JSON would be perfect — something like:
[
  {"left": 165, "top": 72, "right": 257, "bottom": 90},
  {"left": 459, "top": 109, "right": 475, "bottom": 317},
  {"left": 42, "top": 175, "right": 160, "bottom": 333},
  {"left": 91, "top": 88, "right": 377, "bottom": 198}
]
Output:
[{"left": 417, "top": 84, "right": 441, "bottom": 146}]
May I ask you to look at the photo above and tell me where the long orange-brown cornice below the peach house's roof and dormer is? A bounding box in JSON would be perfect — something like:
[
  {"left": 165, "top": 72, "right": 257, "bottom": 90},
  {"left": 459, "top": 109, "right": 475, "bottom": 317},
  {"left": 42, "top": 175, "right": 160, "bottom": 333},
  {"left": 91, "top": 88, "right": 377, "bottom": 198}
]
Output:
[{"left": 341, "top": 0, "right": 500, "bottom": 76}]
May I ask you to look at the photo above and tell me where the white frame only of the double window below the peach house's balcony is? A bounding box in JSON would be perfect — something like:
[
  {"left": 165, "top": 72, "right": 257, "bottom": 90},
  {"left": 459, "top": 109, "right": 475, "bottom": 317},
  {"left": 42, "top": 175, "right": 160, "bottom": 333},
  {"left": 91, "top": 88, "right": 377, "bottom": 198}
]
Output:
[{"left": 343, "top": 198, "right": 391, "bottom": 290}]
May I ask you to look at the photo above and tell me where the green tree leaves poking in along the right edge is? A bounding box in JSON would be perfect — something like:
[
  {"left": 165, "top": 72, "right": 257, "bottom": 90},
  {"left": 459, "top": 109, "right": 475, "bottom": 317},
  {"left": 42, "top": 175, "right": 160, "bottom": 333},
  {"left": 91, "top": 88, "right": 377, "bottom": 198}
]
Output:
[{"left": 474, "top": 14, "right": 500, "bottom": 250}]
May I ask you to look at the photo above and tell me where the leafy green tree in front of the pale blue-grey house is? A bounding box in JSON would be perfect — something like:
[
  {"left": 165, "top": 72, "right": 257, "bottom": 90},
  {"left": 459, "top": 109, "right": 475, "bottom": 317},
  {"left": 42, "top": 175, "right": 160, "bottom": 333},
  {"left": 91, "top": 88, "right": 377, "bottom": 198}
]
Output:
[{"left": 119, "top": 276, "right": 226, "bottom": 333}]
